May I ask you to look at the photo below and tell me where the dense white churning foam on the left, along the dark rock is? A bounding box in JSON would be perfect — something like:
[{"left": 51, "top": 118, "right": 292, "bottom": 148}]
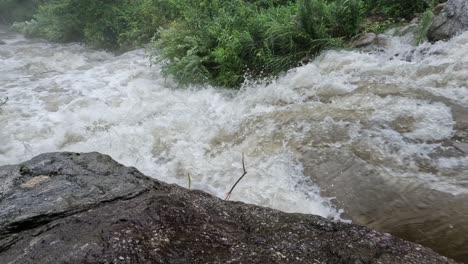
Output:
[{"left": 0, "top": 29, "right": 339, "bottom": 219}]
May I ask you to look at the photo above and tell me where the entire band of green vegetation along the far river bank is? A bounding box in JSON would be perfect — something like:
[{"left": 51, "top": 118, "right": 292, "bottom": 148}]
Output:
[{"left": 0, "top": 0, "right": 436, "bottom": 87}]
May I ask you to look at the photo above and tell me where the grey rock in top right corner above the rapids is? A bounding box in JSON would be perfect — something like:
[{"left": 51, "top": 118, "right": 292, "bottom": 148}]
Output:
[{"left": 428, "top": 0, "right": 468, "bottom": 41}]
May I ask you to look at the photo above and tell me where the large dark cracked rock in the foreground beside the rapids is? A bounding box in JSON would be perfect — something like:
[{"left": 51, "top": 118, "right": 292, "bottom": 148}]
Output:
[{"left": 0, "top": 153, "right": 455, "bottom": 264}]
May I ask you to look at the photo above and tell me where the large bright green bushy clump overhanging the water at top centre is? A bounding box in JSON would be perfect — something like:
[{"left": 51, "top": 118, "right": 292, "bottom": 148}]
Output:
[{"left": 153, "top": 0, "right": 362, "bottom": 87}]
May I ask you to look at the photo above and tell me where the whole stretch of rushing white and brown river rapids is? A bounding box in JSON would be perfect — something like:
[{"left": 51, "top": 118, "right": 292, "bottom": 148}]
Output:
[{"left": 0, "top": 25, "right": 468, "bottom": 263}]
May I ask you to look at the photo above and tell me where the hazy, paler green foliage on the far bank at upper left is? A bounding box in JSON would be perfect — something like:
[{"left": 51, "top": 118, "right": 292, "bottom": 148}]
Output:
[{"left": 15, "top": 0, "right": 180, "bottom": 50}]
